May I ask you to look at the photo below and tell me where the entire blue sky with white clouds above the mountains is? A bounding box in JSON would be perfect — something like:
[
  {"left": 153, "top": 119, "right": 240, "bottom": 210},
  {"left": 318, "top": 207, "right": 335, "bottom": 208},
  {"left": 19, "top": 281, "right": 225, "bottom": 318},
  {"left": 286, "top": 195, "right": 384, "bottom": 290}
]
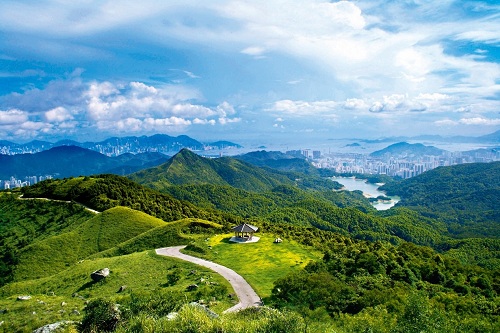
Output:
[{"left": 0, "top": 0, "right": 500, "bottom": 143}]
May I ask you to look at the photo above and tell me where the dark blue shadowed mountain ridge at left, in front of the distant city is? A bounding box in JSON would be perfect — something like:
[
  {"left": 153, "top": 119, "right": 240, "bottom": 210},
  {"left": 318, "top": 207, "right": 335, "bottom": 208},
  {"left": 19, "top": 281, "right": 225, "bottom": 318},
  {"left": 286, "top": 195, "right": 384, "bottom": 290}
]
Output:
[{"left": 0, "top": 146, "right": 169, "bottom": 180}]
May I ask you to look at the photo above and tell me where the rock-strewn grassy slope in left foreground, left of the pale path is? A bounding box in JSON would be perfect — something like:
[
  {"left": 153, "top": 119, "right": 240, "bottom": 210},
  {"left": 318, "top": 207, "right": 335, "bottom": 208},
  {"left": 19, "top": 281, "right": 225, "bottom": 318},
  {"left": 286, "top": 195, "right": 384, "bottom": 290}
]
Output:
[{"left": 0, "top": 250, "right": 233, "bottom": 332}]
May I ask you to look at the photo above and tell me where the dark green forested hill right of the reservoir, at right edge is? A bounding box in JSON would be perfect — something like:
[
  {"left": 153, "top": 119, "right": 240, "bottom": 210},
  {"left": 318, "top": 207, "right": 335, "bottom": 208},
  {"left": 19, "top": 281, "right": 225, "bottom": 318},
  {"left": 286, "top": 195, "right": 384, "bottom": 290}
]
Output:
[{"left": 381, "top": 162, "right": 500, "bottom": 238}]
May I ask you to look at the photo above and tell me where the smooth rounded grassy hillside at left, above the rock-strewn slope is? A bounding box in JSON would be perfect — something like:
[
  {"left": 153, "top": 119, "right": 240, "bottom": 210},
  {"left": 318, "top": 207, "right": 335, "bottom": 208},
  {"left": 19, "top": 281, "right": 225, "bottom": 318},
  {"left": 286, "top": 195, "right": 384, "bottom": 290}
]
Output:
[{"left": 14, "top": 207, "right": 165, "bottom": 281}]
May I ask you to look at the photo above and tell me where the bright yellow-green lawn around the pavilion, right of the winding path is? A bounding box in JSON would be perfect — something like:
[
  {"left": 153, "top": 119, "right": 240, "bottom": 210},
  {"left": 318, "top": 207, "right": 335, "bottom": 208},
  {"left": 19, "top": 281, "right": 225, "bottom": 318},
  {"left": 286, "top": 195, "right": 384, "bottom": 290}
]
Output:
[{"left": 191, "top": 233, "right": 322, "bottom": 301}]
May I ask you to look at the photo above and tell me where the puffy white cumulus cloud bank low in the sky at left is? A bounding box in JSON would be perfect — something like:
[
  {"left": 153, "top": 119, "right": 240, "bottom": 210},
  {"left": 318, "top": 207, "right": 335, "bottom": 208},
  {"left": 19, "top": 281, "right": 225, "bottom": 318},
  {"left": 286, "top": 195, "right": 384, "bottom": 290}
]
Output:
[{"left": 0, "top": 79, "right": 241, "bottom": 138}]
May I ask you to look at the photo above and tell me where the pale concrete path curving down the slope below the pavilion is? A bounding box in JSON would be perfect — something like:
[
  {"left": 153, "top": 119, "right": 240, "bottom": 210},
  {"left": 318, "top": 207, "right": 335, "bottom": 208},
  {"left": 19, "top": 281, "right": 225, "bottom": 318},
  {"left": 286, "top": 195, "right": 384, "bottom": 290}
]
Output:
[{"left": 156, "top": 245, "right": 262, "bottom": 312}]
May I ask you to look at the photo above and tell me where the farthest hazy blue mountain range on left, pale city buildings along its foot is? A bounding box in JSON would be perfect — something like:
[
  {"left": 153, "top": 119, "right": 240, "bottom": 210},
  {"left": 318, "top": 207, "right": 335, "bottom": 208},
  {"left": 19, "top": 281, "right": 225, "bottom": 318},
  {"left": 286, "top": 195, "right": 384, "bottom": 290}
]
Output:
[{"left": 0, "top": 134, "right": 241, "bottom": 156}]
